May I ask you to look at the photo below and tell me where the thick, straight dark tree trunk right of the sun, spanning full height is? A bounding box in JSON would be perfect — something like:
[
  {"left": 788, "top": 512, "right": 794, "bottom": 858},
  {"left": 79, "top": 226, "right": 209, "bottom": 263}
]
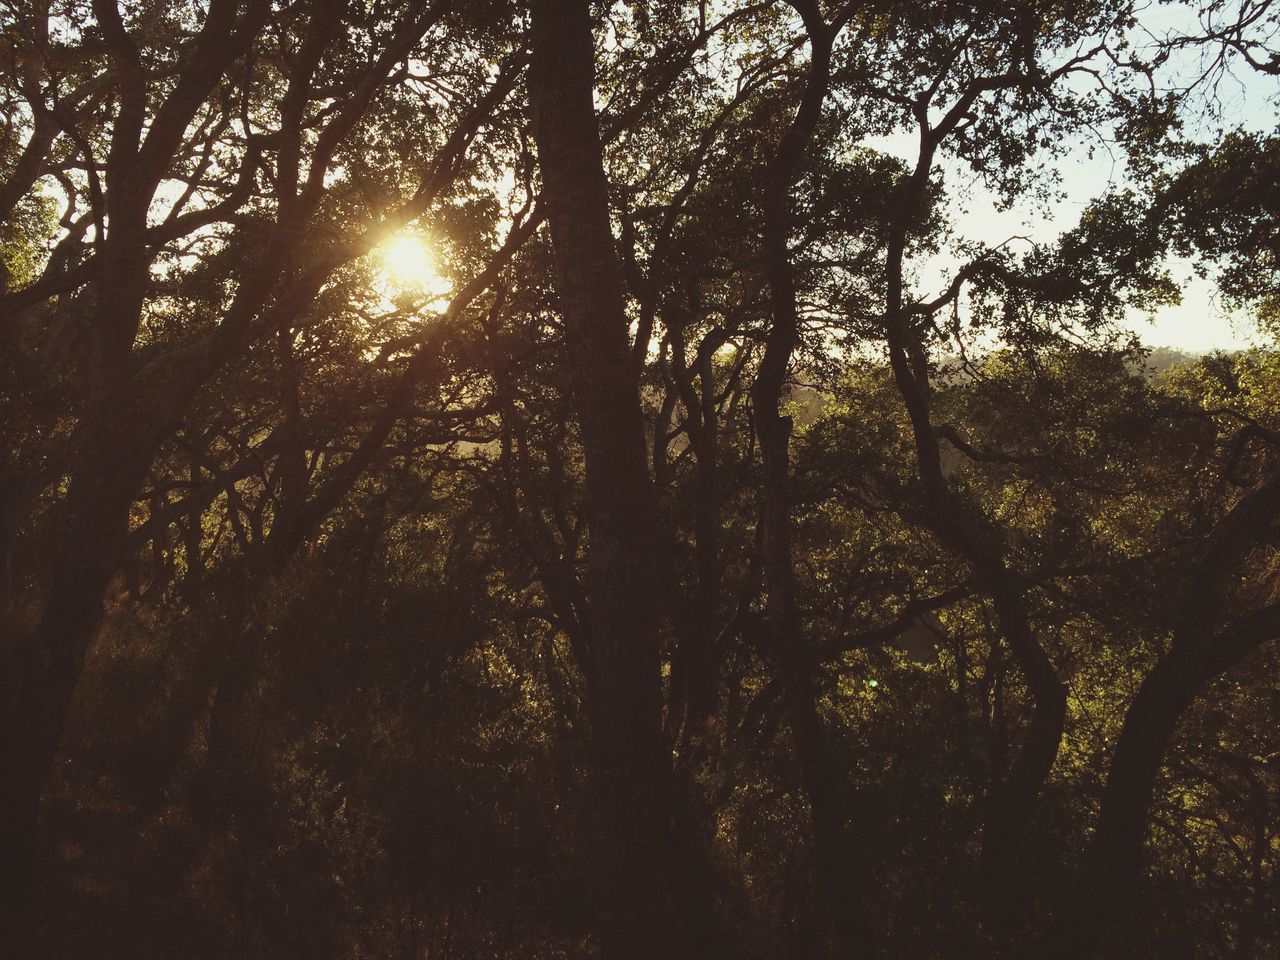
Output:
[{"left": 530, "top": 0, "right": 709, "bottom": 960}]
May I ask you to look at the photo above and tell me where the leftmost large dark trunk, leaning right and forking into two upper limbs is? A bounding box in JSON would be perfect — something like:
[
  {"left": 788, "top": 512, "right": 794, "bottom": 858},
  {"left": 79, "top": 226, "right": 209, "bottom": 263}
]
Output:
[{"left": 0, "top": 1, "right": 259, "bottom": 911}]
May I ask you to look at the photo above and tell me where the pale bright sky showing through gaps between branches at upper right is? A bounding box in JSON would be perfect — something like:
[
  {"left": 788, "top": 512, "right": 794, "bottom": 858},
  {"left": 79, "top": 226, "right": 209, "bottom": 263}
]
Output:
[{"left": 867, "top": 5, "right": 1280, "bottom": 353}]
